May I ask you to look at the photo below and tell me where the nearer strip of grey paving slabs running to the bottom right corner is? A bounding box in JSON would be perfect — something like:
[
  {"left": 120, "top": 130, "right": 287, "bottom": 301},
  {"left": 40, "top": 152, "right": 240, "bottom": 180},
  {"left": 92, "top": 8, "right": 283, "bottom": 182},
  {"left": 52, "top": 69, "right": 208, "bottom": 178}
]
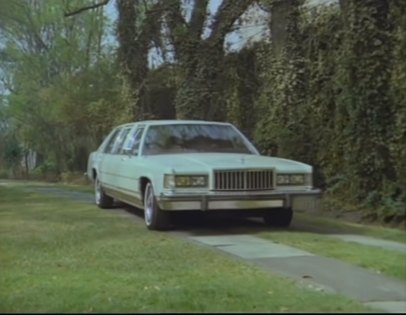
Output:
[{"left": 189, "top": 235, "right": 406, "bottom": 313}]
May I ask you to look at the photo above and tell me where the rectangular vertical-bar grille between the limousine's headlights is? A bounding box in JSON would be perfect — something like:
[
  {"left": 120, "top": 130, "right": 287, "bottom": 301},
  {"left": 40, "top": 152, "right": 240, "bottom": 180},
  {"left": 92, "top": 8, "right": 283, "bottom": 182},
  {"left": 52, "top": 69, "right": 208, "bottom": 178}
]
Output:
[{"left": 214, "top": 170, "right": 273, "bottom": 190}]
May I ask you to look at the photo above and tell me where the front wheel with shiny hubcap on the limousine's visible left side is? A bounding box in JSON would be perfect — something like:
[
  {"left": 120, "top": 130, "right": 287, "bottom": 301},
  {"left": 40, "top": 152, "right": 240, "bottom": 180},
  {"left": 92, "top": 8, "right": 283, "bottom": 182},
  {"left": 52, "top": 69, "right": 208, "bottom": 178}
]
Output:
[{"left": 144, "top": 183, "right": 169, "bottom": 230}]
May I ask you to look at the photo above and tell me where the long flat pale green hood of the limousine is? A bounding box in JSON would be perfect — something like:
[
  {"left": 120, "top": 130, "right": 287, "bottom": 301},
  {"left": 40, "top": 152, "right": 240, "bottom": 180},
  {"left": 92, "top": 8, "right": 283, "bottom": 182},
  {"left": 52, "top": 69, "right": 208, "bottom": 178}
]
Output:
[{"left": 145, "top": 153, "right": 312, "bottom": 173}]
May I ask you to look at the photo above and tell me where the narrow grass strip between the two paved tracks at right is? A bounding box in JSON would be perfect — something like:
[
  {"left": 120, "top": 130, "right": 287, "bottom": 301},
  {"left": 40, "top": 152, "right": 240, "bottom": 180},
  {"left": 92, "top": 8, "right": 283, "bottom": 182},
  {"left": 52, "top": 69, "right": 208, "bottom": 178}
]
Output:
[{"left": 256, "top": 231, "right": 406, "bottom": 280}]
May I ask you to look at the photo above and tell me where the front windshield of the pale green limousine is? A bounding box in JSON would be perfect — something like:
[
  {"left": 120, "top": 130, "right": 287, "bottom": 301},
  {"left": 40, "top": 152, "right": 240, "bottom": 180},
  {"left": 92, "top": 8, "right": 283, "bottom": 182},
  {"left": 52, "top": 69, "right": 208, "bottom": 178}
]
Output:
[{"left": 143, "top": 124, "right": 255, "bottom": 155}]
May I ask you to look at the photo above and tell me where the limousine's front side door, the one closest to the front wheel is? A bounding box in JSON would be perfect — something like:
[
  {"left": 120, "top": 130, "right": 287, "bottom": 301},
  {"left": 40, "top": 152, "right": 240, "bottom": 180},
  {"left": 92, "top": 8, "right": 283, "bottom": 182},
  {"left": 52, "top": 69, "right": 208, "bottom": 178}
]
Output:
[{"left": 117, "top": 125, "right": 145, "bottom": 205}]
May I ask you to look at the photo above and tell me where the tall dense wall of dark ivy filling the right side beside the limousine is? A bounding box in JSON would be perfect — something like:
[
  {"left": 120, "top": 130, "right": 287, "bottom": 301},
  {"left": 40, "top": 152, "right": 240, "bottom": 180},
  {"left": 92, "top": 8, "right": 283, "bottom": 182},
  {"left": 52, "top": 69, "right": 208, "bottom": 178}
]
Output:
[{"left": 254, "top": 0, "right": 406, "bottom": 217}]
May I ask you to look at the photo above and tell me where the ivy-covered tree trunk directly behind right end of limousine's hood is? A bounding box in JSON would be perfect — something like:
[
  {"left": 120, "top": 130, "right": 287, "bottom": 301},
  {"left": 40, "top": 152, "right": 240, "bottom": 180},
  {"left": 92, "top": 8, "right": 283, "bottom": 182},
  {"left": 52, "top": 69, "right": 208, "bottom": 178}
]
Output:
[{"left": 255, "top": 2, "right": 314, "bottom": 162}]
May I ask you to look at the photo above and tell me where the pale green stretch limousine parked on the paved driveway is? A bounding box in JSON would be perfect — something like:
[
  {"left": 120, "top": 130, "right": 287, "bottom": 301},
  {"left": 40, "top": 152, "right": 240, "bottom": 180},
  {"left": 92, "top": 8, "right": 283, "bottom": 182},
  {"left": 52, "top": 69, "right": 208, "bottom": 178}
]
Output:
[{"left": 87, "top": 120, "right": 320, "bottom": 230}]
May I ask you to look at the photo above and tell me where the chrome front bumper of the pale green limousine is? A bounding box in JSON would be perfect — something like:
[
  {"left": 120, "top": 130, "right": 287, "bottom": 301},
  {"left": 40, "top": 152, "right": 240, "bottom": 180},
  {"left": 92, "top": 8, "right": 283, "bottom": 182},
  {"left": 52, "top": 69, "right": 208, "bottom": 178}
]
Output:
[{"left": 157, "top": 189, "right": 321, "bottom": 211}]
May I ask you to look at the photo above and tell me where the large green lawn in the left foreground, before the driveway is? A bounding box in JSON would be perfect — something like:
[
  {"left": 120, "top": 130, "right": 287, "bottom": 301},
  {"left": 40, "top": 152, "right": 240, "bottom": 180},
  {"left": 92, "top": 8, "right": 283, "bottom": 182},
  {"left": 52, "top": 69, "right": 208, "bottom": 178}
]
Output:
[{"left": 0, "top": 186, "right": 370, "bottom": 313}]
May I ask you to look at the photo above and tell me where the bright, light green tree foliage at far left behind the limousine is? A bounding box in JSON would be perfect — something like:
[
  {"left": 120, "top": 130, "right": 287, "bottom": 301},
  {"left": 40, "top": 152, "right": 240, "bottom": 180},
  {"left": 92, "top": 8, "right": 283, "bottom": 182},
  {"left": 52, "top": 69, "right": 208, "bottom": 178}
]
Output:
[{"left": 0, "top": 1, "right": 133, "bottom": 175}]
